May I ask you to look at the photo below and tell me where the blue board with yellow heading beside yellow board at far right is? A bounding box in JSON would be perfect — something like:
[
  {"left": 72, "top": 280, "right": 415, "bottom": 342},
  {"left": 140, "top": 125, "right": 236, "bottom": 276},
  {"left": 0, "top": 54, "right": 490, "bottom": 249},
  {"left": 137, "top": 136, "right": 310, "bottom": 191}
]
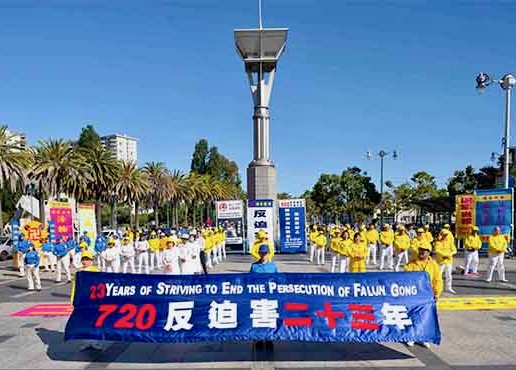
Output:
[{"left": 475, "top": 189, "right": 513, "bottom": 250}]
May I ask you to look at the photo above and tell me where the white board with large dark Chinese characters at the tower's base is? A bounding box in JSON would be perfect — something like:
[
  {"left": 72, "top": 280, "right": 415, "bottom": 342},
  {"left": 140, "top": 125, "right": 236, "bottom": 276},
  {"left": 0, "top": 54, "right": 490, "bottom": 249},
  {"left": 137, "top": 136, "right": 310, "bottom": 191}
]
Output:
[{"left": 247, "top": 199, "right": 275, "bottom": 251}]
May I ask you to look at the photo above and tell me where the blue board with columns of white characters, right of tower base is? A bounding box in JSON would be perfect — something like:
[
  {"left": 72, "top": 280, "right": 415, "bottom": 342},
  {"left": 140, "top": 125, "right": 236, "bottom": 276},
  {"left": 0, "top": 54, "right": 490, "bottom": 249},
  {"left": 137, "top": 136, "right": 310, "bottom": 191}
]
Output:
[{"left": 278, "top": 199, "right": 306, "bottom": 253}]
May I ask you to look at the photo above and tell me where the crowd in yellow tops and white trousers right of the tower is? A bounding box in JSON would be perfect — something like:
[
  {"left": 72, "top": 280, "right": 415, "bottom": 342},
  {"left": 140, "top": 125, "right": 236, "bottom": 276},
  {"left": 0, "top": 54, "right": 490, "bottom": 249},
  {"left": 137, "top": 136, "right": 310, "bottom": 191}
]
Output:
[{"left": 308, "top": 223, "right": 507, "bottom": 294}]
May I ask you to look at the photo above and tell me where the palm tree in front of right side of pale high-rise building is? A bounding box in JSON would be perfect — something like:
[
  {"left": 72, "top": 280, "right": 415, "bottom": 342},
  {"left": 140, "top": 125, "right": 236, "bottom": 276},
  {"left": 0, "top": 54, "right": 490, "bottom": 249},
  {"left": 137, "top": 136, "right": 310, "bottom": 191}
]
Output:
[{"left": 115, "top": 162, "right": 150, "bottom": 228}]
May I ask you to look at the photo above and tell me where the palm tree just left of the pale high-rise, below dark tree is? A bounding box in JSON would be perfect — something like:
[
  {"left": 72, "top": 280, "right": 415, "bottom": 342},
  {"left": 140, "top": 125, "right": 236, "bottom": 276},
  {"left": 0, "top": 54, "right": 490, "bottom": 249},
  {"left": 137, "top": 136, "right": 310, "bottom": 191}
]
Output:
[{"left": 79, "top": 144, "right": 121, "bottom": 233}]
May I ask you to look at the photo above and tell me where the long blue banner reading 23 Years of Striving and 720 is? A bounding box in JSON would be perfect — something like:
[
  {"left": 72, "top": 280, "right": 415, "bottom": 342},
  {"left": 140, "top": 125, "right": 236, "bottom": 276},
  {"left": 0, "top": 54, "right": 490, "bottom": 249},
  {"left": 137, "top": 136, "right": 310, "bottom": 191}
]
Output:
[{"left": 65, "top": 272, "right": 441, "bottom": 344}]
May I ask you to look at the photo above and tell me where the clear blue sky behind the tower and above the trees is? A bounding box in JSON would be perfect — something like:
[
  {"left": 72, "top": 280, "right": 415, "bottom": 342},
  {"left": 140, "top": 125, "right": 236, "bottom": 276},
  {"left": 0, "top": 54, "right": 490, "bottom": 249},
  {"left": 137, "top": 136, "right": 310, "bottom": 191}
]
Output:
[{"left": 0, "top": 0, "right": 516, "bottom": 194}]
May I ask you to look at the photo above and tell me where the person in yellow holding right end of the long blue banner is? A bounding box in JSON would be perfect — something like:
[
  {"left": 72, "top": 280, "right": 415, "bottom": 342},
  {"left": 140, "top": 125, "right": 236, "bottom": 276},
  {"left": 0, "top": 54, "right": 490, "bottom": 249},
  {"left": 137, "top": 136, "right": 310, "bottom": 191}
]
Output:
[{"left": 405, "top": 244, "right": 443, "bottom": 348}]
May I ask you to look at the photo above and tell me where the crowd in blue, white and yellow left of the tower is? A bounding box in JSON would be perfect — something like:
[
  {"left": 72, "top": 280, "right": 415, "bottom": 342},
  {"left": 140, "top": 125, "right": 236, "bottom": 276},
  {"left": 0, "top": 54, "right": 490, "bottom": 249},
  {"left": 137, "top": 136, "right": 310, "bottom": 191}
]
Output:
[{"left": 15, "top": 227, "right": 226, "bottom": 290}]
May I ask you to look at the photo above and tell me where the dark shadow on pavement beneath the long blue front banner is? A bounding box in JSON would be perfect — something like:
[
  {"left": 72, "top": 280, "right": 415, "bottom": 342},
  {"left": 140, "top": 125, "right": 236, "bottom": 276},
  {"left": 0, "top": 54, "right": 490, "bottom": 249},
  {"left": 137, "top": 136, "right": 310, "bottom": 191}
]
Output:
[{"left": 36, "top": 328, "right": 412, "bottom": 363}]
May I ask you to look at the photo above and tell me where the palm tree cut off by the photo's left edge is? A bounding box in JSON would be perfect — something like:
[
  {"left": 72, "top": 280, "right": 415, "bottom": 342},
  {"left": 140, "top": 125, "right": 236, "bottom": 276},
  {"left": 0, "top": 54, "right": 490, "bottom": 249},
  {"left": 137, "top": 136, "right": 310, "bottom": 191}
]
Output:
[{"left": 0, "top": 125, "right": 32, "bottom": 234}]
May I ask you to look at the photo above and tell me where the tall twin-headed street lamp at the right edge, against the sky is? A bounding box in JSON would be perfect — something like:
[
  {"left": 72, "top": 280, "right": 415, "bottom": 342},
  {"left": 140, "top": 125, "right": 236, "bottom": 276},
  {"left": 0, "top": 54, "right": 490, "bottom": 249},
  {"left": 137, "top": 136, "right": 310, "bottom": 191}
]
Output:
[{"left": 475, "top": 72, "right": 516, "bottom": 189}]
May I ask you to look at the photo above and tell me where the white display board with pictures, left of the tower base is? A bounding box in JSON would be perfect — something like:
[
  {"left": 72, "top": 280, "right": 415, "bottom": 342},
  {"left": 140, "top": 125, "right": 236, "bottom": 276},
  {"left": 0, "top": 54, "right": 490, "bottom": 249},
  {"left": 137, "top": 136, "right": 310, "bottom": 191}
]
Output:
[{"left": 217, "top": 200, "right": 244, "bottom": 245}]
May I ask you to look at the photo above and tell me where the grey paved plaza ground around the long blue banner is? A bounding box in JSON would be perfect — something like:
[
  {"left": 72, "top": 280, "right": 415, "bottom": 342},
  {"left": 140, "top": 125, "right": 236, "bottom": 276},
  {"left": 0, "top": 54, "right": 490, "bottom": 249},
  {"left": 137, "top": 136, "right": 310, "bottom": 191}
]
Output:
[{"left": 0, "top": 255, "right": 516, "bottom": 370}]
